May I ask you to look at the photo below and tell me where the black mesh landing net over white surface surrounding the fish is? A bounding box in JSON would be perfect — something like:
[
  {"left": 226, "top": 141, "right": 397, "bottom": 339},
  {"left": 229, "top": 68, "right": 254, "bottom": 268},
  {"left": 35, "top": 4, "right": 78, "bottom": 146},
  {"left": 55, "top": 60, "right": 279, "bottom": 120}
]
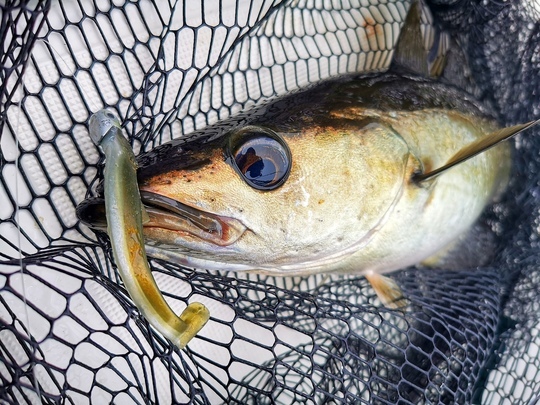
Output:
[{"left": 0, "top": 0, "right": 540, "bottom": 404}]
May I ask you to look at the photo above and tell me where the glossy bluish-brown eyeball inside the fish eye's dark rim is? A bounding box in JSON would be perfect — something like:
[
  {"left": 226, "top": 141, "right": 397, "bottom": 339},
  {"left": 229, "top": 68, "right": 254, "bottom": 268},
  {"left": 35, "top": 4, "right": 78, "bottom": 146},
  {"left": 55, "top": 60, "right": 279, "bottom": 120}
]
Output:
[{"left": 234, "top": 134, "right": 290, "bottom": 190}]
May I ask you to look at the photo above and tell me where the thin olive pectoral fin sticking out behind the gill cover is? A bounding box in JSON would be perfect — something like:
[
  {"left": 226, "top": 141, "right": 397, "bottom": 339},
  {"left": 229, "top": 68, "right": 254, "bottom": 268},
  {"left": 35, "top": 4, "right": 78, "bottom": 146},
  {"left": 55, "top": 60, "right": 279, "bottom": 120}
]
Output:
[{"left": 413, "top": 119, "right": 540, "bottom": 182}]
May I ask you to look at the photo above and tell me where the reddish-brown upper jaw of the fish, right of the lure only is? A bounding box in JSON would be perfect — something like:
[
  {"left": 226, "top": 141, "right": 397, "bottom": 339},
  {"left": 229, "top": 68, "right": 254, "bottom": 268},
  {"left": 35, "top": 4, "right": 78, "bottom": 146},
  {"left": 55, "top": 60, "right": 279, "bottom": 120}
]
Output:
[{"left": 140, "top": 190, "right": 247, "bottom": 246}]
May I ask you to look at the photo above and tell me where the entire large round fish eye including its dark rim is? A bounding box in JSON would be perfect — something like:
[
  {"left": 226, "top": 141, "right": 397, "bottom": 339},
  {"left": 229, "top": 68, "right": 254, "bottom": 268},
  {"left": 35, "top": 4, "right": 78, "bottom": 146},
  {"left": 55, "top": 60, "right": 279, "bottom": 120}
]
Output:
[{"left": 229, "top": 126, "right": 291, "bottom": 190}]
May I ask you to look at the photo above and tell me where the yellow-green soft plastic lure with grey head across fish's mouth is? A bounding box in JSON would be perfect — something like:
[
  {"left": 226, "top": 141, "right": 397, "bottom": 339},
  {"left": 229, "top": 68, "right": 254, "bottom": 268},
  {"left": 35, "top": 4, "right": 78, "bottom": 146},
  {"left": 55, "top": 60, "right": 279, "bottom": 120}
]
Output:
[{"left": 89, "top": 110, "right": 210, "bottom": 349}]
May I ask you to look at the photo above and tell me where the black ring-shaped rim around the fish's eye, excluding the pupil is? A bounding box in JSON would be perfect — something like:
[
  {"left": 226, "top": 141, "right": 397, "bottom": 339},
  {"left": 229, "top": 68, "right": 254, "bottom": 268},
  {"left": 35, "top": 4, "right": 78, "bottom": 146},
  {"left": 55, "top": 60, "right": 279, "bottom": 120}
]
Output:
[{"left": 225, "top": 125, "right": 292, "bottom": 191}]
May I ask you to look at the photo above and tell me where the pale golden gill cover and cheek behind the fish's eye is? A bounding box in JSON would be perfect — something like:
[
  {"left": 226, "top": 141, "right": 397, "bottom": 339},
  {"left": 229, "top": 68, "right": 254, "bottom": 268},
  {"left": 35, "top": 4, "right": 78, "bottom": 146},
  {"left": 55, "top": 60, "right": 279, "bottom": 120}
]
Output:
[{"left": 280, "top": 125, "right": 409, "bottom": 255}]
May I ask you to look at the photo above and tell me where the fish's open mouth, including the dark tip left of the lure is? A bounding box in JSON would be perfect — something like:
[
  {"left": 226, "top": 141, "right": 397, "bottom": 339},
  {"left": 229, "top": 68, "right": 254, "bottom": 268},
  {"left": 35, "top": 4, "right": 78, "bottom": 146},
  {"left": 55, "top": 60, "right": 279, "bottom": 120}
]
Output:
[{"left": 77, "top": 190, "right": 247, "bottom": 246}]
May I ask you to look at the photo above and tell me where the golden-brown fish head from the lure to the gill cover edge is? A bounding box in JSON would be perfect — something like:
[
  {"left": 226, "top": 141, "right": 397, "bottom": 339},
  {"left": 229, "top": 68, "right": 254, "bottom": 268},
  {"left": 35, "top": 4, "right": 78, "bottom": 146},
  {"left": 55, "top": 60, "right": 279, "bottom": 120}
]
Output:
[{"left": 135, "top": 110, "right": 420, "bottom": 275}]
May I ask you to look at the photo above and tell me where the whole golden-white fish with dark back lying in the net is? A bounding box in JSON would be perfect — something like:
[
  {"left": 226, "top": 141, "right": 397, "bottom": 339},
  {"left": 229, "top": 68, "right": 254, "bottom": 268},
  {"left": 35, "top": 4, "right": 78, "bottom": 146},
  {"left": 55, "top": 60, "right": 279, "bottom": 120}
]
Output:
[{"left": 77, "top": 72, "right": 536, "bottom": 307}]
